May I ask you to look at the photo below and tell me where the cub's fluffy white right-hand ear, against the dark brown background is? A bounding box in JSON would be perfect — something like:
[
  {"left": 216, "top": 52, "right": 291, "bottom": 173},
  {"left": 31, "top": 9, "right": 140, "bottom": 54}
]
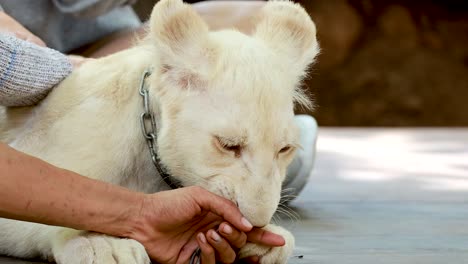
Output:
[{"left": 254, "top": 1, "right": 320, "bottom": 75}]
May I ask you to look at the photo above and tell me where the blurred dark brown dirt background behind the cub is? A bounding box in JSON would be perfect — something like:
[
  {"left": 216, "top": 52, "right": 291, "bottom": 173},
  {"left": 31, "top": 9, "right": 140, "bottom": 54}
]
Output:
[{"left": 135, "top": 0, "right": 468, "bottom": 126}]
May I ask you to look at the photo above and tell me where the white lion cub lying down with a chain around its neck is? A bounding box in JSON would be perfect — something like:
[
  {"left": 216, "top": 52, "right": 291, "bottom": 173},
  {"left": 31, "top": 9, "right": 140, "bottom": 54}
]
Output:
[{"left": 0, "top": 0, "right": 318, "bottom": 264}]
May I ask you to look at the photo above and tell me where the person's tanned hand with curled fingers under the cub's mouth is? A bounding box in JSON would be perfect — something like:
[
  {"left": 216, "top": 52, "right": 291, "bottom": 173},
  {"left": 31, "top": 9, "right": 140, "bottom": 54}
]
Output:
[{"left": 125, "top": 187, "right": 284, "bottom": 264}]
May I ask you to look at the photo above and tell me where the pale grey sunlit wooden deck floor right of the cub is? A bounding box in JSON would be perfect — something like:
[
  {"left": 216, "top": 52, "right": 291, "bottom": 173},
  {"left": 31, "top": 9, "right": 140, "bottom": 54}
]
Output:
[{"left": 0, "top": 128, "right": 468, "bottom": 264}]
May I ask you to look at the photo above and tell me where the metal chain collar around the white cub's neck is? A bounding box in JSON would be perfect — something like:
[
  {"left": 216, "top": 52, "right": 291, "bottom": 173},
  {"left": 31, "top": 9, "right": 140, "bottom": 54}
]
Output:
[{"left": 140, "top": 69, "right": 182, "bottom": 189}]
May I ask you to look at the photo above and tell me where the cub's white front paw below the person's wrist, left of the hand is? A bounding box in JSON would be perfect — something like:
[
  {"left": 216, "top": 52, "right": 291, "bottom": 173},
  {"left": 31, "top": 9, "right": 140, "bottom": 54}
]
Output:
[{"left": 53, "top": 232, "right": 151, "bottom": 264}]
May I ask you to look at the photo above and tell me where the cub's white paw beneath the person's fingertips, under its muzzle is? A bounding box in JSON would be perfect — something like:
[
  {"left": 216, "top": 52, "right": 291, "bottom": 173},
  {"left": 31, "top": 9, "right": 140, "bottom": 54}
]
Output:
[{"left": 239, "top": 225, "right": 294, "bottom": 264}]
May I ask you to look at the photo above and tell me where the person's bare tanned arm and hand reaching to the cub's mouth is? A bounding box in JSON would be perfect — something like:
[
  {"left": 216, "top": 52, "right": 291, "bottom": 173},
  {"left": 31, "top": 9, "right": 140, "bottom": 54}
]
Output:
[{"left": 0, "top": 143, "right": 284, "bottom": 263}]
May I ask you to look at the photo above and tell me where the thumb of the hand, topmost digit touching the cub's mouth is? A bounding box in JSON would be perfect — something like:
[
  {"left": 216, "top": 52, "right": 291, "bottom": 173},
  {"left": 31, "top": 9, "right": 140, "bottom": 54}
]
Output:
[{"left": 189, "top": 187, "right": 253, "bottom": 232}]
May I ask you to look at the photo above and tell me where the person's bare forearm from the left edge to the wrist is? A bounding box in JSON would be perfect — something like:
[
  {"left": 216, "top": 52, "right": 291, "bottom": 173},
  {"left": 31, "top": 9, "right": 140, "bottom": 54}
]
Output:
[{"left": 0, "top": 143, "right": 144, "bottom": 236}]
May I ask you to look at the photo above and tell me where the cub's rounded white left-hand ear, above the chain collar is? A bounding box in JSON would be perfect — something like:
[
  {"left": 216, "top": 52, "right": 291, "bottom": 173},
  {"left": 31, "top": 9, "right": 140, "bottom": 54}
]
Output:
[{"left": 150, "top": 0, "right": 216, "bottom": 88}]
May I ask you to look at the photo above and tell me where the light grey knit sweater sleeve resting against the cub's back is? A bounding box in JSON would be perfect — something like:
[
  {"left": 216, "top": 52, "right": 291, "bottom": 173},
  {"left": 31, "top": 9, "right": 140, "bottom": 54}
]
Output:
[{"left": 0, "top": 33, "right": 72, "bottom": 106}]
